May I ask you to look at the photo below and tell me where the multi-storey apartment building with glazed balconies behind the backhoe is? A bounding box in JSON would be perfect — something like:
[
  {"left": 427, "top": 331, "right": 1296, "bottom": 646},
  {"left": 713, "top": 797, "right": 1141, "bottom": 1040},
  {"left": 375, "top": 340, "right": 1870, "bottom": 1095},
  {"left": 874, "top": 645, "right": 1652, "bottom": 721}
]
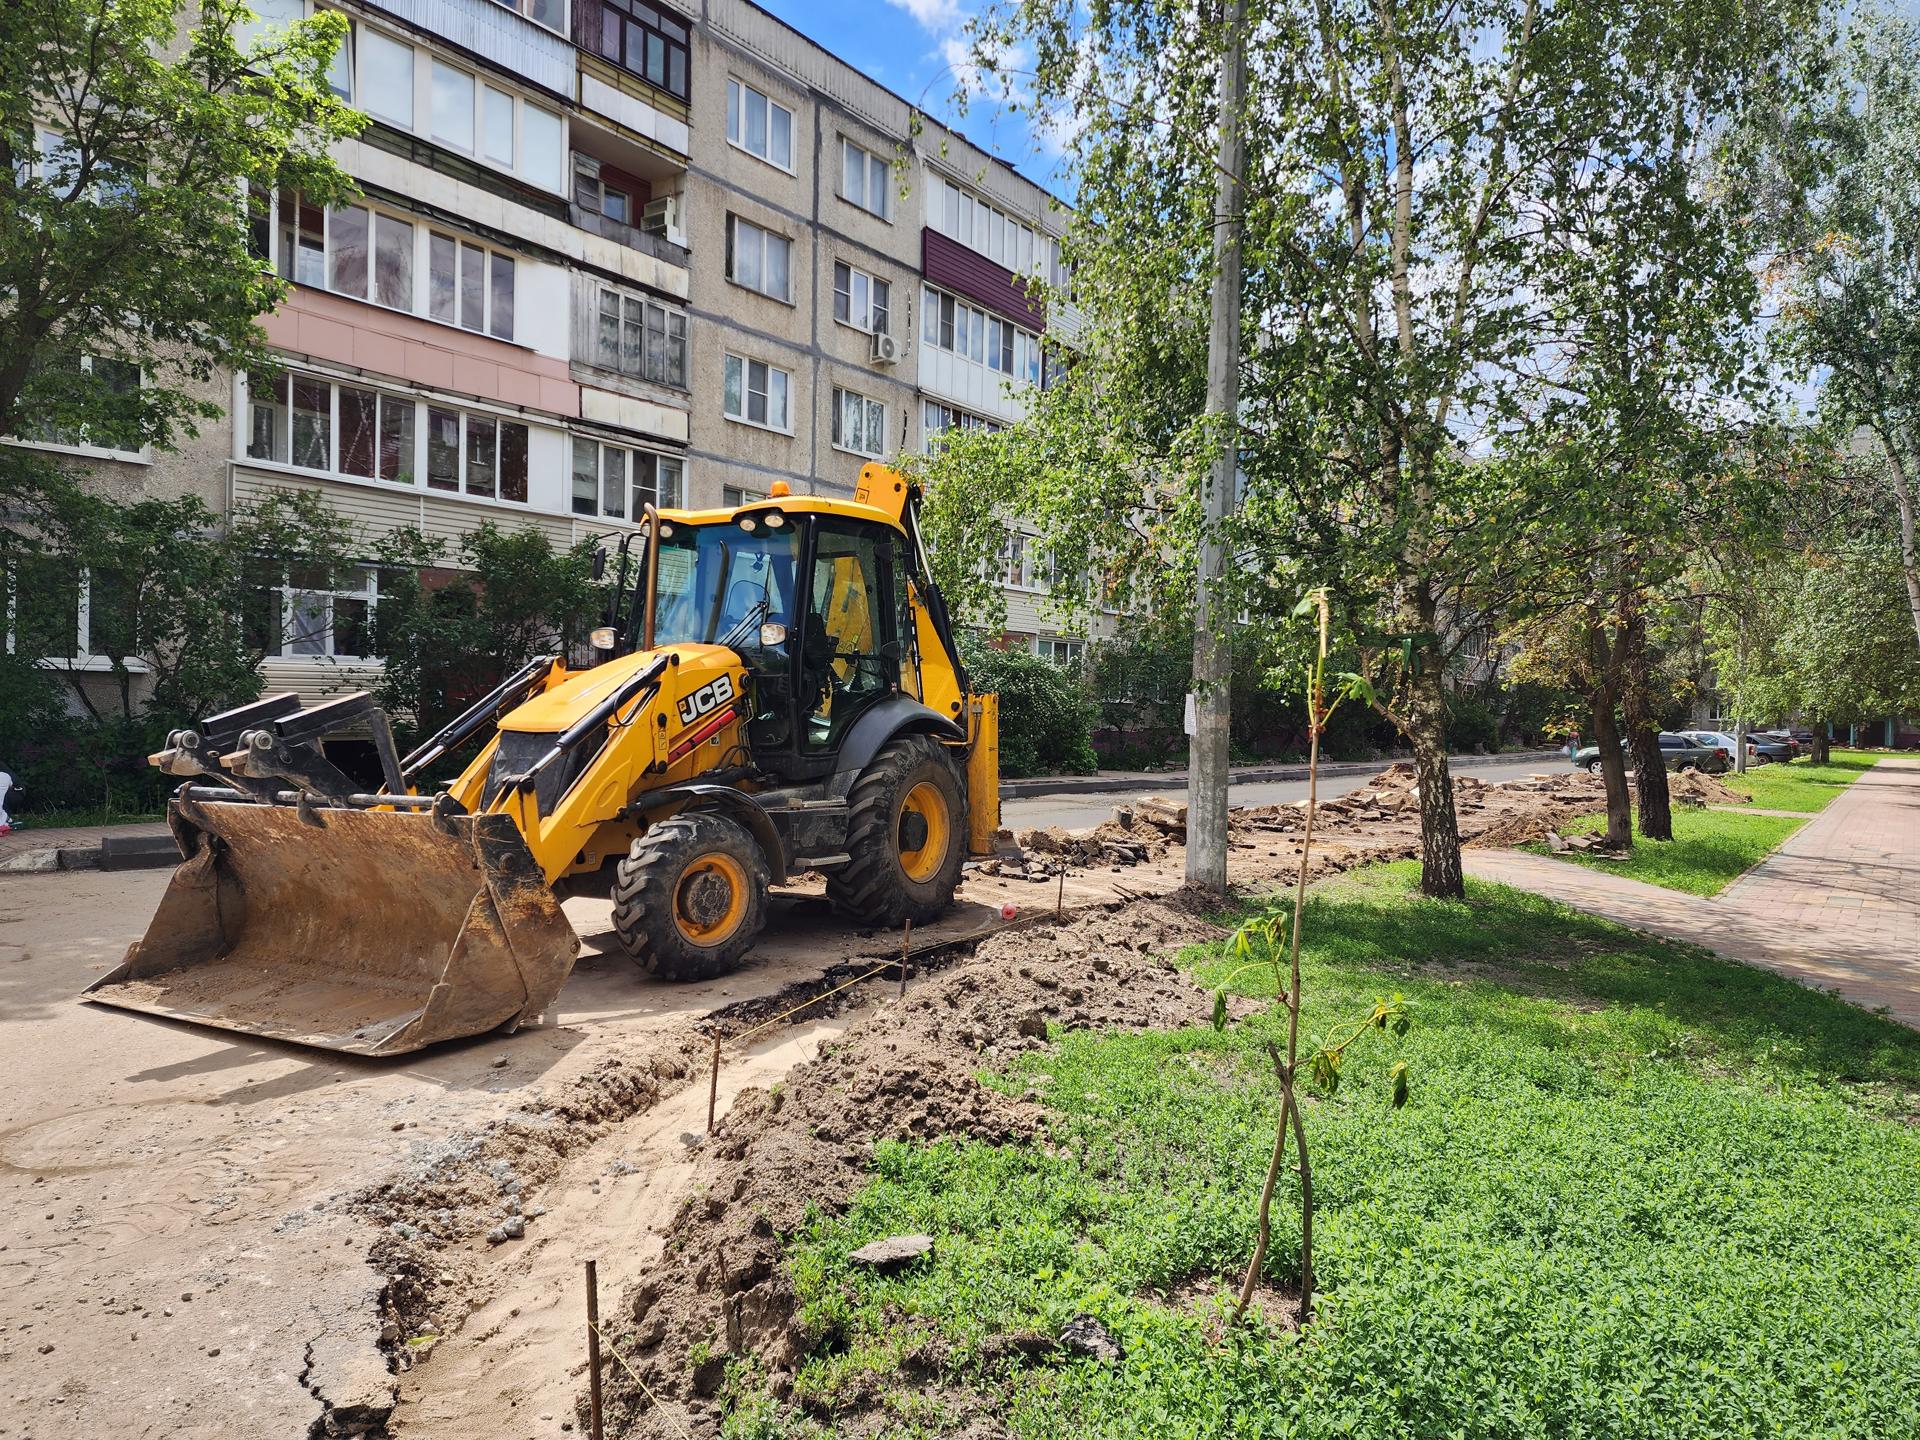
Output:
[{"left": 3, "top": 0, "right": 1079, "bottom": 718}]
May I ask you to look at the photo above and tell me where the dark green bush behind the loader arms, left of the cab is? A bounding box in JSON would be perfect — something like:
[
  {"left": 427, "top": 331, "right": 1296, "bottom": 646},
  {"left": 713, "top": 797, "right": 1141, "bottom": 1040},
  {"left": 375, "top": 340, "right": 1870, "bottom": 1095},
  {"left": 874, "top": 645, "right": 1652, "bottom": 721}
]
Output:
[{"left": 374, "top": 522, "right": 607, "bottom": 733}]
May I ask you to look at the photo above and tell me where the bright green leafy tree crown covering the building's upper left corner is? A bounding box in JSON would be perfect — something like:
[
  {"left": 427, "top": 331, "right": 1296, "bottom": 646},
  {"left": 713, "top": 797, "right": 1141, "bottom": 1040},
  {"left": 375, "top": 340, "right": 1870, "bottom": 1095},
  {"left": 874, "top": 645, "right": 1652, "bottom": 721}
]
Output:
[{"left": 0, "top": 0, "right": 365, "bottom": 456}]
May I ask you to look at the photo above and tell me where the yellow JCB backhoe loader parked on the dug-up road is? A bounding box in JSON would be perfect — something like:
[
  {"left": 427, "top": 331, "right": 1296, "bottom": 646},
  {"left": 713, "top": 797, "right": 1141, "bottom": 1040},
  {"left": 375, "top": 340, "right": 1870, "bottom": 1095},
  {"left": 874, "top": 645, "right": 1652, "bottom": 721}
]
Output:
[{"left": 86, "top": 465, "right": 1000, "bottom": 1054}]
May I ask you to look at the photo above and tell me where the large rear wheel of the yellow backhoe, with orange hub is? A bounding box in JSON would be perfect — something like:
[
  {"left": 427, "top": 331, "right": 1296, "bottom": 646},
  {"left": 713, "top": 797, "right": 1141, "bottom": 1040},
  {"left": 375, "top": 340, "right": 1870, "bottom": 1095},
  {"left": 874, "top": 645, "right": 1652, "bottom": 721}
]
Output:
[{"left": 828, "top": 735, "right": 966, "bottom": 929}]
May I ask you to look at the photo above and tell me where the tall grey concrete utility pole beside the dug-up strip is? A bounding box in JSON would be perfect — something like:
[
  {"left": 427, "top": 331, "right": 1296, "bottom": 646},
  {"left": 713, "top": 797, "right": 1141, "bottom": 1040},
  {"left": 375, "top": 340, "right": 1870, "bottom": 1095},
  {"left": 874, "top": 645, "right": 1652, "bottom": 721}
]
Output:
[{"left": 1187, "top": 0, "right": 1246, "bottom": 895}]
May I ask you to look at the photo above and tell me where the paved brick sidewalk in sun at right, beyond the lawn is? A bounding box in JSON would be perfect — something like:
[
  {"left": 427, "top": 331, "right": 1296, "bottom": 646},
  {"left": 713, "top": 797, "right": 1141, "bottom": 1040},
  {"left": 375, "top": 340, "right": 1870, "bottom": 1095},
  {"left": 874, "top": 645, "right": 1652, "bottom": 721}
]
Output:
[{"left": 1467, "top": 758, "right": 1920, "bottom": 1029}]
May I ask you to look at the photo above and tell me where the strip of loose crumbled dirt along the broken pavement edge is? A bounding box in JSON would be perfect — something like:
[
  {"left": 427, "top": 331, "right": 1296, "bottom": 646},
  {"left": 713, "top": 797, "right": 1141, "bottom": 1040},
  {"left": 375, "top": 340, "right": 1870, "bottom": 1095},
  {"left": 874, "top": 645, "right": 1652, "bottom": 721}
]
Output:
[{"left": 342, "top": 1033, "right": 707, "bottom": 1371}]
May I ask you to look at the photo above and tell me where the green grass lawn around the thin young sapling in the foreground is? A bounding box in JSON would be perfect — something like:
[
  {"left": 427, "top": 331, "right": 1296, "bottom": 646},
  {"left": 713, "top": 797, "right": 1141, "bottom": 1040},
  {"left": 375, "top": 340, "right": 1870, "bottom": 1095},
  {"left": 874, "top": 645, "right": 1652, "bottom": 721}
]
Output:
[{"left": 728, "top": 864, "right": 1920, "bottom": 1440}]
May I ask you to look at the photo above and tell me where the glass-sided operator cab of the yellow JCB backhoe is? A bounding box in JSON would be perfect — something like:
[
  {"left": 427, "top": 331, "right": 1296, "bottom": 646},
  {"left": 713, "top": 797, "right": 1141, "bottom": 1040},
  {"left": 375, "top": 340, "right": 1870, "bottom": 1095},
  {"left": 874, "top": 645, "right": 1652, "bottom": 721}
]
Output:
[{"left": 636, "top": 501, "right": 920, "bottom": 781}]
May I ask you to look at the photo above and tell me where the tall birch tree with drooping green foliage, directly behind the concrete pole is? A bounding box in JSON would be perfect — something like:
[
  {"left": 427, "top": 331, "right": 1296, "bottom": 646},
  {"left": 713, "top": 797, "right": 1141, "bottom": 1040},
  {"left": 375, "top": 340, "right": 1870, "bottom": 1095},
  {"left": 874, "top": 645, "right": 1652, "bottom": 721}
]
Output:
[{"left": 929, "top": 0, "right": 1812, "bottom": 895}]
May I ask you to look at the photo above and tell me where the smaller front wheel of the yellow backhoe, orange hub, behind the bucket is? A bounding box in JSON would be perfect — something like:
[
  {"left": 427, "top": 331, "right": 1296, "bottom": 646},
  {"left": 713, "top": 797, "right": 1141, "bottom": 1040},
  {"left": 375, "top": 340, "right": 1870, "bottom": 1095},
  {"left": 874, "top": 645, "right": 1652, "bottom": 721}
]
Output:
[{"left": 612, "top": 810, "right": 768, "bottom": 979}]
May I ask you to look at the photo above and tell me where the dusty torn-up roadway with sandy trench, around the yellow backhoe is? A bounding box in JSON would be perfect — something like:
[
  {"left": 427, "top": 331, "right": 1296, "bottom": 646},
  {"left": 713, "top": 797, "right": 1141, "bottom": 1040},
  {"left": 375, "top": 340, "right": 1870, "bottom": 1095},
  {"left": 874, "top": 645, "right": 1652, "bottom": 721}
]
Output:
[{"left": 0, "top": 760, "right": 1605, "bottom": 1440}]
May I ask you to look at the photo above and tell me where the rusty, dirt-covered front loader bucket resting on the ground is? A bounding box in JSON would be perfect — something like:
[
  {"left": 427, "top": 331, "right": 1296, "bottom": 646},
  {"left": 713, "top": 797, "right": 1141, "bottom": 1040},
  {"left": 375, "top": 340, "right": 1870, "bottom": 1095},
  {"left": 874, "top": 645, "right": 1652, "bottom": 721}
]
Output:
[{"left": 84, "top": 799, "right": 580, "bottom": 1054}]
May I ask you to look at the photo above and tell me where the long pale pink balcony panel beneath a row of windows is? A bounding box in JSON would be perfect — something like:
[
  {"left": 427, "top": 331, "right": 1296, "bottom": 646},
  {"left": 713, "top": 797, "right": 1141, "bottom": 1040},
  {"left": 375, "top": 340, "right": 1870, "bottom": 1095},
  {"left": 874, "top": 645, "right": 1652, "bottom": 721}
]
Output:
[{"left": 263, "top": 286, "right": 580, "bottom": 417}]
